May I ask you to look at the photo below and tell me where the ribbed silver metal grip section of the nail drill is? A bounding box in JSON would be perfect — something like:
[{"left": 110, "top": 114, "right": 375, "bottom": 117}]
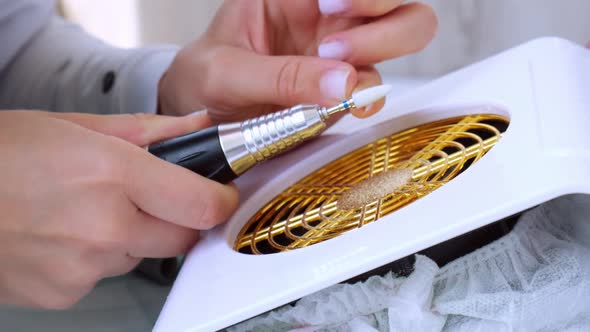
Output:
[{"left": 219, "top": 105, "right": 327, "bottom": 175}]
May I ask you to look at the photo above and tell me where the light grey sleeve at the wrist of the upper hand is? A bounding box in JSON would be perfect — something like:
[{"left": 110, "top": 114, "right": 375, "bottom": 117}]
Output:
[{"left": 0, "top": 17, "right": 178, "bottom": 114}]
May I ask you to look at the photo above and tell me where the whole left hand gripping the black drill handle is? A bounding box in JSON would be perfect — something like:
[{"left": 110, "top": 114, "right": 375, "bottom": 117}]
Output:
[{"left": 0, "top": 111, "right": 238, "bottom": 309}]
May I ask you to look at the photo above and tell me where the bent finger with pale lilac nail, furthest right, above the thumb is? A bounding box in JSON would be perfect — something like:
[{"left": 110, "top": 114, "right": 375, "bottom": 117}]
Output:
[{"left": 318, "top": 3, "right": 437, "bottom": 65}]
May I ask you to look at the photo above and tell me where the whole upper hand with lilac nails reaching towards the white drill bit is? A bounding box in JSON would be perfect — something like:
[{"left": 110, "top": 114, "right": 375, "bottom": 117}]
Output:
[{"left": 159, "top": 0, "right": 437, "bottom": 122}]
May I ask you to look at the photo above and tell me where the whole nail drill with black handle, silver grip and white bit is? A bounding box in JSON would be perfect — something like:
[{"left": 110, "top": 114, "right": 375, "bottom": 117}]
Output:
[{"left": 148, "top": 85, "right": 392, "bottom": 183}]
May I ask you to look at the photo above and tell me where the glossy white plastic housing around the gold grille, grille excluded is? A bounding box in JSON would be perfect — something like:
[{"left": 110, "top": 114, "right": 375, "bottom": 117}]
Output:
[{"left": 155, "top": 38, "right": 590, "bottom": 332}]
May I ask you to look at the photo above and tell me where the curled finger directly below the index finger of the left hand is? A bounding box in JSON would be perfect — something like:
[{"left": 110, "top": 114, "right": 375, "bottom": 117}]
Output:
[{"left": 126, "top": 211, "right": 199, "bottom": 260}]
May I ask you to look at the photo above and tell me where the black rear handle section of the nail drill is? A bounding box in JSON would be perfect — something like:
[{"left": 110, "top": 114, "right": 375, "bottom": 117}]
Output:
[{"left": 148, "top": 126, "right": 238, "bottom": 183}]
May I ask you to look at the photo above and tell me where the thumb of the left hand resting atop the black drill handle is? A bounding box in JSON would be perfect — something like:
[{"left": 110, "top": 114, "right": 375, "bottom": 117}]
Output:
[{"left": 48, "top": 112, "right": 211, "bottom": 146}]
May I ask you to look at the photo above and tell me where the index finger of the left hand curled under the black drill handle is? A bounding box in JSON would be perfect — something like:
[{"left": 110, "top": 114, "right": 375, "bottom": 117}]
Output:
[{"left": 120, "top": 145, "right": 238, "bottom": 229}]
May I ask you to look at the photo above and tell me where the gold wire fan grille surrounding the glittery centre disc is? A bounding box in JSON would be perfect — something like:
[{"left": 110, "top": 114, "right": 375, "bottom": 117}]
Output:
[{"left": 234, "top": 114, "right": 508, "bottom": 255}]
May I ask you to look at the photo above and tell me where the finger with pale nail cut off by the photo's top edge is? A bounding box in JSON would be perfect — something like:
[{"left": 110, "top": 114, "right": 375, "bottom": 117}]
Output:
[{"left": 319, "top": 0, "right": 404, "bottom": 17}]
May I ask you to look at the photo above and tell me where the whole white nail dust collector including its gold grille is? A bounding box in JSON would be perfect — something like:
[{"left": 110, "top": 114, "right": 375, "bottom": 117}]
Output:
[{"left": 155, "top": 38, "right": 590, "bottom": 332}]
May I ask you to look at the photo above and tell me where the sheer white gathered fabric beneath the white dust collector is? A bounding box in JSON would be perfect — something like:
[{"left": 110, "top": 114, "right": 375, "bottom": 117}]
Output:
[{"left": 228, "top": 195, "right": 590, "bottom": 332}]
